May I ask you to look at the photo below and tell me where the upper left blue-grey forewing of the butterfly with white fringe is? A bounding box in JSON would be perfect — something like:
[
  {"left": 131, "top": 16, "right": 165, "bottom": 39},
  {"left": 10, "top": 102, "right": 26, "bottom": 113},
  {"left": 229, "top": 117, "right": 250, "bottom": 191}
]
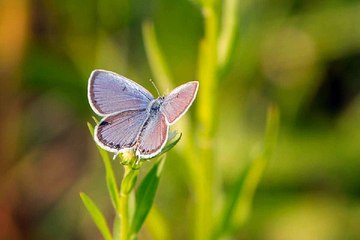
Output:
[{"left": 88, "top": 70, "right": 154, "bottom": 116}]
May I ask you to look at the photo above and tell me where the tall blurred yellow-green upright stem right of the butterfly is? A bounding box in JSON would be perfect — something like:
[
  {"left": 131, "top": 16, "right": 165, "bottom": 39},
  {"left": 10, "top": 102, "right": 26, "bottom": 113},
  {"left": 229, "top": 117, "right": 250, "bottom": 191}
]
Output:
[{"left": 194, "top": 4, "right": 219, "bottom": 240}]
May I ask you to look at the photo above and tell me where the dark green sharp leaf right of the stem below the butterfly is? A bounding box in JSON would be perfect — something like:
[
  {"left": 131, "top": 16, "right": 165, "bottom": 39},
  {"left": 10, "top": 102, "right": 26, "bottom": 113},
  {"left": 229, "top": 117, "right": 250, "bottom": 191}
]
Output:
[{"left": 131, "top": 157, "right": 165, "bottom": 234}]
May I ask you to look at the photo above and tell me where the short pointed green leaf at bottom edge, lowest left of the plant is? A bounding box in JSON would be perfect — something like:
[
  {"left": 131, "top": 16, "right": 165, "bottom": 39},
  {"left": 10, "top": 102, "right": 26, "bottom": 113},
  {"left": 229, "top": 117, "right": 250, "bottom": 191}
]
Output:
[{"left": 80, "top": 193, "right": 112, "bottom": 240}]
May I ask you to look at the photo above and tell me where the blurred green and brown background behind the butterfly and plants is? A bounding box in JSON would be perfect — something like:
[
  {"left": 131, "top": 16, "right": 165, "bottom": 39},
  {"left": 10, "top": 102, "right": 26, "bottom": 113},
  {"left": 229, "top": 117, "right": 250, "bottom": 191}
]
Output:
[{"left": 0, "top": 0, "right": 360, "bottom": 240}]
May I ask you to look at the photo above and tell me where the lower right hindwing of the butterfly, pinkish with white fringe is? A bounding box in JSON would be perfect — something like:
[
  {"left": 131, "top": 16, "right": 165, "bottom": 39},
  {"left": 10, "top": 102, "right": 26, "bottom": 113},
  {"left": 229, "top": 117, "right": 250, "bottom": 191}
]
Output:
[{"left": 137, "top": 111, "right": 169, "bottom": 158}]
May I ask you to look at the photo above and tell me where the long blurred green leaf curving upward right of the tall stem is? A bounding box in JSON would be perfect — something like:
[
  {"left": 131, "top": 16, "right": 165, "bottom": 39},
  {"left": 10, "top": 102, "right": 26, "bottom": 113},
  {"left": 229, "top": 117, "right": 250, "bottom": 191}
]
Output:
[{"left": 213, "top": 106, "right": 279, "bottom": 239}]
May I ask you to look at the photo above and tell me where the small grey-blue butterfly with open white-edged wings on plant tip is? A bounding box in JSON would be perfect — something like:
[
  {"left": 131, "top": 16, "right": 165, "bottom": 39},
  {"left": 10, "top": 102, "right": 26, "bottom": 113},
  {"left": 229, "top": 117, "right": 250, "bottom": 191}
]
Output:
[{"left": 88, "top": 69, "right": 199, "bottom": 159}]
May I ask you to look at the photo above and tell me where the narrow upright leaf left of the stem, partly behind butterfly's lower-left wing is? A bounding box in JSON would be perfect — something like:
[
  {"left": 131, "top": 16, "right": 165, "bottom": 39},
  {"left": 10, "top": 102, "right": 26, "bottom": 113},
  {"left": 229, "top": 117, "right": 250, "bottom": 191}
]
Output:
[{"left": 87, "top": 122, "right": 120, "bottom": 212}]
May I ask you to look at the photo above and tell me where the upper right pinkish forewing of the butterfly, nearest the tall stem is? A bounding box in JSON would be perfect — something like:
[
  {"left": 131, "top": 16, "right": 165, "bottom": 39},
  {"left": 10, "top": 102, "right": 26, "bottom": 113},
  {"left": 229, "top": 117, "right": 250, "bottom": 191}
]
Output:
[{"left": 161, "top": 81, "right": 199, "bottom": 124}]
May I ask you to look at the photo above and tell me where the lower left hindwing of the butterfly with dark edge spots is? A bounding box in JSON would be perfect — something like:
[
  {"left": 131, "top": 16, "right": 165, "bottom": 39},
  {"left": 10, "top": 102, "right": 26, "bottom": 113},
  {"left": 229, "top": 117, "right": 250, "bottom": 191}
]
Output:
[{"left": 94, "top": 109, "right": 148, "bottom": 152}]
